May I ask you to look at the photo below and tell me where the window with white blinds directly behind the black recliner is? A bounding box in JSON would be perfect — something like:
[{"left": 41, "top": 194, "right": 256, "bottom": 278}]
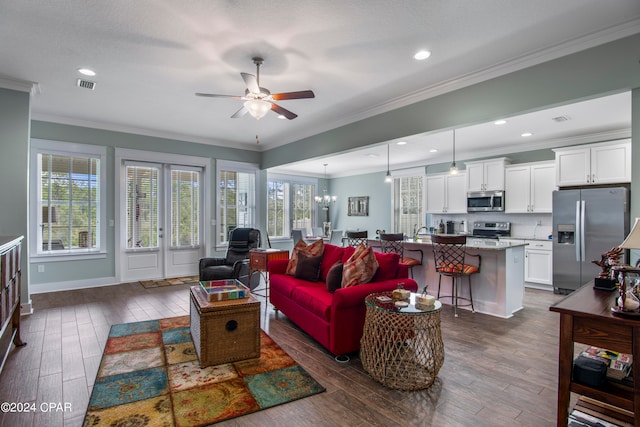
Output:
[{"left": 216, "top": 161, "right": 257, "bottom": 245}]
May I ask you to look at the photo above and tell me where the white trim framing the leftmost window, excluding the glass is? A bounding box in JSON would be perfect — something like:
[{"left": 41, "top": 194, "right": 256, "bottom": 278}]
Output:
[{"left": 28, "top": 138, "right": 107, "bottom": 262}]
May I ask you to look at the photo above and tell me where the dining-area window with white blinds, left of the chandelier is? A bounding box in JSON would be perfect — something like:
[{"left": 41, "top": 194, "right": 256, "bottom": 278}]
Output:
[{"left": 267, "top": 176, "right": 317, "bottom": 238}]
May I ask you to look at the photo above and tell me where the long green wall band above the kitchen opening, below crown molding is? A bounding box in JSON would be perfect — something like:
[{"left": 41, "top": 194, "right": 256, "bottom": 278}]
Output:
[{"left": 262, "top": 34, "right": 640, "bottom": 168}]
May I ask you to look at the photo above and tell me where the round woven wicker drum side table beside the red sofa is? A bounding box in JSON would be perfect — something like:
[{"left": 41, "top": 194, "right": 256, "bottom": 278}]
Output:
[{"left": 360, "top": 292, "right": 444, "bottom": 390}]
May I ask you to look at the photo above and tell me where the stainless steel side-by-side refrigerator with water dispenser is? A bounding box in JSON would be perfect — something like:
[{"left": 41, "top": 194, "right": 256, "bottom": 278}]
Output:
[{"left": 553, "top": 187, "right": 629, "bottom": 294}]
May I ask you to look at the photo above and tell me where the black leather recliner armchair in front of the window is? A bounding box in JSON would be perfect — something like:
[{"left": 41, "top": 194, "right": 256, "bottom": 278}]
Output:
[{"left": 199, "top": 228, "right": 260, "bottom": 289}]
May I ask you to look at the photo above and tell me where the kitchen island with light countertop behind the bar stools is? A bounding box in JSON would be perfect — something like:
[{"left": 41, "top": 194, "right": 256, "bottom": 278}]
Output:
[{"left": 369, "top": 237, "right": 526, "bottom": 318}]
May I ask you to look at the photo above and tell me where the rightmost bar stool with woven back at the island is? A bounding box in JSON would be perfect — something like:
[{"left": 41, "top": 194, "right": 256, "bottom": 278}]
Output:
[{"left": 431, "top": 234, "right": 482, "bottom": 317}]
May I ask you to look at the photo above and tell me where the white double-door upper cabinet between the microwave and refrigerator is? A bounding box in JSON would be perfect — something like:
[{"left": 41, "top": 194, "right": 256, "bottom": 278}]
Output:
[{"left": 504, "top": 161, "right": 556, "bottom": 213}]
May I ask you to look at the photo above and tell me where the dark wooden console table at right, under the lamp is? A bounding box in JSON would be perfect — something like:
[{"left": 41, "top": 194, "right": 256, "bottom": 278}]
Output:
[{"left": 549, "top": 282, "right": 640, "bottom": 427}]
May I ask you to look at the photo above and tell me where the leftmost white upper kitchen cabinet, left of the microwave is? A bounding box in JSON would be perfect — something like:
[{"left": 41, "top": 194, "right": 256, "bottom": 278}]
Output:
[{"left": 426, "top": 173, "right": 467, "bottom": 213}]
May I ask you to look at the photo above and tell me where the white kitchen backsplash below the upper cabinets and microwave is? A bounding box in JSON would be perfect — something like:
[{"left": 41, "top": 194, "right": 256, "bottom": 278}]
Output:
[{"left": 427, "top": 212, "right": 552, "bottom": 239}]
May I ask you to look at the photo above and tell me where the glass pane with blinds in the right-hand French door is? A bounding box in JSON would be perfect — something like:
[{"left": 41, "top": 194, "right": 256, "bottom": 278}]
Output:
[{"left": 171, "top": 169, "right": 200, "bottom": 248}]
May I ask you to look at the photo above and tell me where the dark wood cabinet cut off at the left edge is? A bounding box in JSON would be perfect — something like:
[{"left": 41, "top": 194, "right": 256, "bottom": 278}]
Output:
[{"left": 0, "top": 236, "right": 26, "bottom": 370}]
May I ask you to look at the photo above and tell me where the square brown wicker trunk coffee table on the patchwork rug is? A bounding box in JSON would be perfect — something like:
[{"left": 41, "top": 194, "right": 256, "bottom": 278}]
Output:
[{"left": 190, "top": 286, "right": 260, "bottom": 368}]
